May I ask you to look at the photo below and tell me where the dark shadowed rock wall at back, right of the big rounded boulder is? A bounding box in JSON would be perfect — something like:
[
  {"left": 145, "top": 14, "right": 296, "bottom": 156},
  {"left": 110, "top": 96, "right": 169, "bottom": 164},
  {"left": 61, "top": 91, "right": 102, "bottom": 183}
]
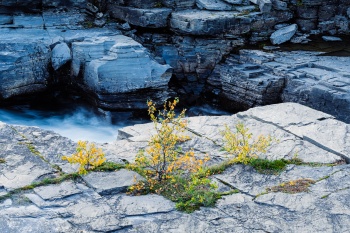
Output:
[{"left": 108, "top": 0, "right": 350, "bottom": 103}]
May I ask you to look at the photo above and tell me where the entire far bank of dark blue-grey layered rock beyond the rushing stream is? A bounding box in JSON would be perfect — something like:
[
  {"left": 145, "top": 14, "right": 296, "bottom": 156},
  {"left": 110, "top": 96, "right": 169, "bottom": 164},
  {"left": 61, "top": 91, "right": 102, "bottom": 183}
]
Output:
[{"left": 0, "top": 0, "right": 350, "bottom": 114}]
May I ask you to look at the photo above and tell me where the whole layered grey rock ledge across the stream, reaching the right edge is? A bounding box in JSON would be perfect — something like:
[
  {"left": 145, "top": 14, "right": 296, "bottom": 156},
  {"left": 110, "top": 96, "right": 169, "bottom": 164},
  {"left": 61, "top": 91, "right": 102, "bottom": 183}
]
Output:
[{"left": 209, "top": 50, "right": 350, "bottom": 122}]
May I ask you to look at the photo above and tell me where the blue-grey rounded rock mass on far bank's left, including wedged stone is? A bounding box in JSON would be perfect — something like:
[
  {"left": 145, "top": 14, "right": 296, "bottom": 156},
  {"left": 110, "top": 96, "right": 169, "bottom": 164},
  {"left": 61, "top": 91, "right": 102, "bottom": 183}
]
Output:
[{"left": 0, "top": 1, "right": 173, "bottom": 109}]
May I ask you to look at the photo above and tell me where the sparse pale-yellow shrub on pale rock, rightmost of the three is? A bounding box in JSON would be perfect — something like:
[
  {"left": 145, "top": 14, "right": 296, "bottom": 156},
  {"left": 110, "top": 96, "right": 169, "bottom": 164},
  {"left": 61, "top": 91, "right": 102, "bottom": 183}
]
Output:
[{"left": 221, "top": 122, "right": 272, "bottom": 164}]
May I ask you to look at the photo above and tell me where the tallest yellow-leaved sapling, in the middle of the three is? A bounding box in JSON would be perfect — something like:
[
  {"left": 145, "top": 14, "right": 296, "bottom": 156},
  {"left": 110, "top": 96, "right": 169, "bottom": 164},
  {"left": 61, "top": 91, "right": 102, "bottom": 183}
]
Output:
[{"left": 131, "top": 98, "right": 208, "bottom": 182}]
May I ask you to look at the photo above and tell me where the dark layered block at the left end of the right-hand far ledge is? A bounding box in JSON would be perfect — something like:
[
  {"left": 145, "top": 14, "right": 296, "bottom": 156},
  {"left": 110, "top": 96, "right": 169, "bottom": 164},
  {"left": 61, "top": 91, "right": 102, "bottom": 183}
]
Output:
[{"left": 214, "top": 51, "right": 285, "bottom": 110}]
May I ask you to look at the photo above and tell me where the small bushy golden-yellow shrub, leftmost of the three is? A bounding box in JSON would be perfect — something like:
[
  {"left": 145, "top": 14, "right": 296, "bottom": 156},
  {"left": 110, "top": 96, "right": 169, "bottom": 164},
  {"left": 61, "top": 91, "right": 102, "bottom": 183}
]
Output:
[{"left": 62, "top": 141, "right": 106, "bottom": 174}]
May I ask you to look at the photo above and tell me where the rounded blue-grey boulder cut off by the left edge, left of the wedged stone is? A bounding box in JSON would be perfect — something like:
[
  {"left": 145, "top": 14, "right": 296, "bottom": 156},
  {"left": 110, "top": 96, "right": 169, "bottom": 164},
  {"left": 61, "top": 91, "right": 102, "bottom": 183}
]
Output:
[{"left": 0, "top": 30, "right": 51, "bottom": 98}]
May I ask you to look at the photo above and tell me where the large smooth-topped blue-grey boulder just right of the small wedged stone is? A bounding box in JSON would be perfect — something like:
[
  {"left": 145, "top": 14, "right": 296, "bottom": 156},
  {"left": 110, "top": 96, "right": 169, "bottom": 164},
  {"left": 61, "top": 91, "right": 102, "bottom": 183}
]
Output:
[{"left": 72, "top": 35, "right": 172, "bottom": 109}]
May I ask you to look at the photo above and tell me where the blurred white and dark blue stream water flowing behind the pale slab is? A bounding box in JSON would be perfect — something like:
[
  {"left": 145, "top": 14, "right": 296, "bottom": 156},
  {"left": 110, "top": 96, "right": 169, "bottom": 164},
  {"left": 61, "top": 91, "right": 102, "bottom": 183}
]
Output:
[{"left": 0, "top": 103, "right": 229, "bottom": 143}]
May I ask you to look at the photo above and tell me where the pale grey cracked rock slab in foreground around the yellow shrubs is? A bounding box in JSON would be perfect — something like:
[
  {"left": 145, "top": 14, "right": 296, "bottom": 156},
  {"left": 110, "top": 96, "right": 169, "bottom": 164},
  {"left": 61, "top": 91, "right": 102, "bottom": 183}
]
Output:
[{"left": 0, "top": 103, "right": 350, "bottom": 233}]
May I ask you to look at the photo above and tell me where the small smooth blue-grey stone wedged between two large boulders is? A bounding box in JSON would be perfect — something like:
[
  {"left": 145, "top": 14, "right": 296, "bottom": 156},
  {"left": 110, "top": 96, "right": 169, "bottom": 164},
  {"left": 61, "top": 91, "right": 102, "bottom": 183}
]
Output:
[{"left": 51, "top": 43, "right": 72, "bottom": 70}]
